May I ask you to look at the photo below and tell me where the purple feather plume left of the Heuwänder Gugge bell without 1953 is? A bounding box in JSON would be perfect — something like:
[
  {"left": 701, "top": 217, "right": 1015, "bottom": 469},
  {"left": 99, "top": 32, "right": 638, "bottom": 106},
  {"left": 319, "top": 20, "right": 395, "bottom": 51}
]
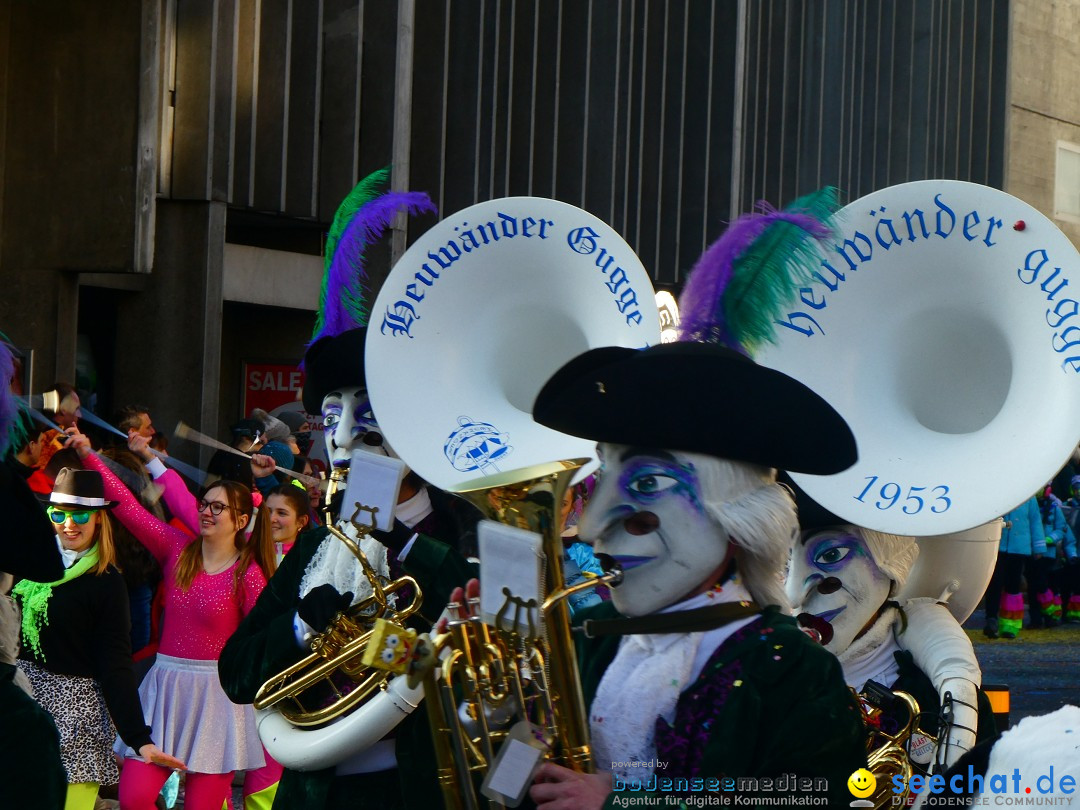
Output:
[{"left": 309, "top": 191, "right": 435, "bottom": 346}]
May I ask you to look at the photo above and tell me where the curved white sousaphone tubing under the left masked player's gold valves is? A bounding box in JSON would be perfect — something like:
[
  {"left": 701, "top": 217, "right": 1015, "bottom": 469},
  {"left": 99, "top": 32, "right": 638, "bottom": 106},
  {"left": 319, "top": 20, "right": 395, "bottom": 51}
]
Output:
[{"left": 255, "top": 676, "right": 423, "bottom": 771}]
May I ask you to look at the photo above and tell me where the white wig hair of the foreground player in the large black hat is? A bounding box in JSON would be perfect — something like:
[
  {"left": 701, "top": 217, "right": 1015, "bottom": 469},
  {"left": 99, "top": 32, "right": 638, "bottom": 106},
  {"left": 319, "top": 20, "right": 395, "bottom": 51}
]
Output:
[{"left": 676, "top": 453, "right": 798, "bottom": 613}]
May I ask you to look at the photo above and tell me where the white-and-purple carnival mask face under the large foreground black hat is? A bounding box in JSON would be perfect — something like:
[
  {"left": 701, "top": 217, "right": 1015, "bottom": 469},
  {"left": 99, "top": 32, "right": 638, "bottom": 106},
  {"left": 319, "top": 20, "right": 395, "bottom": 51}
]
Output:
[{"left": 579, "top": 444, "right": 729, "bottom": 616}]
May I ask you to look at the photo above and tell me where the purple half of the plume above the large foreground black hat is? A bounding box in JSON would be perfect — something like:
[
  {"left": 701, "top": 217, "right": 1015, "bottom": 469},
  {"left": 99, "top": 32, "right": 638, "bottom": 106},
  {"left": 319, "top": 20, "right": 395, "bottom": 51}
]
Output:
[{"left": 679, "top": 202, "right": 833, "bottom": 351}]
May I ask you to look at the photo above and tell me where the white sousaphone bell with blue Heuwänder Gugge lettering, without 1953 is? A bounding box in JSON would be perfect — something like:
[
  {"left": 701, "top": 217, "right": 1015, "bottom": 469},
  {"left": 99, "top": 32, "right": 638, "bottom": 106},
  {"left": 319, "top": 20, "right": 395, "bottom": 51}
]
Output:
[{"left": 365, "top": 197, "right": 660, "bottom": 491}]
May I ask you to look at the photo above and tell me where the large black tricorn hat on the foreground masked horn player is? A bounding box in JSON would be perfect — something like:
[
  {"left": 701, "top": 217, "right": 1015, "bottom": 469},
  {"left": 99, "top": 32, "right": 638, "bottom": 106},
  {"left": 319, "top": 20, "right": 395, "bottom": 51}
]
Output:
[{"left": 532, "top": 342, "right": 859, "bottom": 475}]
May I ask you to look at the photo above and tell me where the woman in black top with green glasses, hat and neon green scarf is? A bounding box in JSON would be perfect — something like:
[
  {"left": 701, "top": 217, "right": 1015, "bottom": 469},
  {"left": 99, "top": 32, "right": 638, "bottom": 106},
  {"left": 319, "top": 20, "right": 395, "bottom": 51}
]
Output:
[{"left": 8, "top": 468, "right": 185, "bottom": 810}]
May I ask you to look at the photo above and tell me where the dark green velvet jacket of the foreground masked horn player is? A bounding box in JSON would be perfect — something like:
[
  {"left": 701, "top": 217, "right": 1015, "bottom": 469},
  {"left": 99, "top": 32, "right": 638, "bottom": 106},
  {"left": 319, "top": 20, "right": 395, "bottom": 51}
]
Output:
[{"left": 575, "top": 603, "right": 866, "bottom": 807}]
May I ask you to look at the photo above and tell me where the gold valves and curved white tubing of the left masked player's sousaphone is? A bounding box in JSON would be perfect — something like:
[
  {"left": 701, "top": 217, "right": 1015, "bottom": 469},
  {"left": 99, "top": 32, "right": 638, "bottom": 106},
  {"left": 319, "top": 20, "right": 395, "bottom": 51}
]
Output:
[{"left": 254, "top": 468, "right": 422, "bottom": 771}]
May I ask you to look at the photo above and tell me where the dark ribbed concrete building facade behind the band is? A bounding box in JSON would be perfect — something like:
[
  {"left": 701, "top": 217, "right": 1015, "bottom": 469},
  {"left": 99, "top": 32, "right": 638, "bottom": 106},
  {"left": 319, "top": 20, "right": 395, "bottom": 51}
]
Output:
[{"left": 0, "top": 0, "right": 1080, "bottom": 462}]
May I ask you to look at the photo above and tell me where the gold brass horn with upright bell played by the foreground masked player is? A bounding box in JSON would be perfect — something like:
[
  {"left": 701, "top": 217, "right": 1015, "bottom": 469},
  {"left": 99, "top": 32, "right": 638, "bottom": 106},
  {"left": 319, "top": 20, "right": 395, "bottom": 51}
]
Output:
[{"left": 424, "top": 461, "right": 620, "bottom": 810}]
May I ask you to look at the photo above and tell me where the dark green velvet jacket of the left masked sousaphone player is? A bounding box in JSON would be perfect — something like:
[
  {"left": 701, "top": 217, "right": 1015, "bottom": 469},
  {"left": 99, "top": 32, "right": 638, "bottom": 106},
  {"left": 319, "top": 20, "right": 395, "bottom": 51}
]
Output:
[{"left": 218, "top": 528, "right": 476, "bottom": 810}]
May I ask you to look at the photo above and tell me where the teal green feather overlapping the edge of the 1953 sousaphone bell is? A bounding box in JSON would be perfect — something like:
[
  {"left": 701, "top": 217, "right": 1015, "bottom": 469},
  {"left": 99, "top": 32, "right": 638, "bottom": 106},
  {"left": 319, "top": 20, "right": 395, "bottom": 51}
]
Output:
[{"left": 724, "top": 186, "right": 838, "bottom": 353}]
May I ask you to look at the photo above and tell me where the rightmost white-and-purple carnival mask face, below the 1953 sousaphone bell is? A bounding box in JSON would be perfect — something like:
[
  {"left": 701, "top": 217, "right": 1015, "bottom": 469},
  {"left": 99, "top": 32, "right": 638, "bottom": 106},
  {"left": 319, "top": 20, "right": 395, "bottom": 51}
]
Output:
[{"left": 787, "top": 529, "right": 892, "bottom": 654}]
